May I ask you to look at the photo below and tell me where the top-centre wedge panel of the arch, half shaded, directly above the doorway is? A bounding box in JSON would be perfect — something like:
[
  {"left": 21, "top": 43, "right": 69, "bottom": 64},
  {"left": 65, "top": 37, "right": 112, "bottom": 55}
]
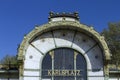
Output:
[{"left": 53, "top": 30, "right": 74, "bottom": 48}]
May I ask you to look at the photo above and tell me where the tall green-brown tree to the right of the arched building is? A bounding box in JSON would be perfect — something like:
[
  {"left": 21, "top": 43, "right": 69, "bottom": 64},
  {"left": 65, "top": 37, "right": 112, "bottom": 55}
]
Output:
[{"left": 102, "top": 23, "right": 120, "bottom": 65}]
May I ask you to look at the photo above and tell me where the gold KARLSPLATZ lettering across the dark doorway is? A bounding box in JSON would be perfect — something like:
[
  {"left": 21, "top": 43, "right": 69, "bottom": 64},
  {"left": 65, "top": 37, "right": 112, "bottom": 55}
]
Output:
[{"left": 47, "top": 70, "right": 81, "bottom": 76}]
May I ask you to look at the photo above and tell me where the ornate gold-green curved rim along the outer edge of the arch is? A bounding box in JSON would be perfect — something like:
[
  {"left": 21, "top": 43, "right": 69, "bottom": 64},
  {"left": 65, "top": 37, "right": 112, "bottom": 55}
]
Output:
[{"left": 18, "top": 21, "right": 110, "bottom": 60}]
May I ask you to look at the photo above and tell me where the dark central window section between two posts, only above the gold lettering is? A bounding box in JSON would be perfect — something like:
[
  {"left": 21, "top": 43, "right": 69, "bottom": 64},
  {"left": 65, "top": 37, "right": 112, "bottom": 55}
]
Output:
[{"left": 54, "top": 49, "right": 74, "bottom": 69}]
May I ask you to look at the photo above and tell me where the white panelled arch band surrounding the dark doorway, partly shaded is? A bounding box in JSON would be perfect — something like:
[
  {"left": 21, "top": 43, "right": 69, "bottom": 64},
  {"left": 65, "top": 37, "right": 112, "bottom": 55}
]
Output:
[{"left": 23, "top": 29, "right": 105, "bottom": 80}]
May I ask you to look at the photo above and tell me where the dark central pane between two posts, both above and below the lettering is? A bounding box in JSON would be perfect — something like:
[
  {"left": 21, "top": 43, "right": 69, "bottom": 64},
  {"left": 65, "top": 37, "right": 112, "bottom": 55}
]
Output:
[{"left": 54, "top": 48, "right": 74, "bottom": 80}]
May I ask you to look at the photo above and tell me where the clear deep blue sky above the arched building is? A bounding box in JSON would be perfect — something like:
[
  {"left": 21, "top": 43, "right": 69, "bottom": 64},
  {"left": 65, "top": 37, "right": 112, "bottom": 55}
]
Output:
[{"left": 0, "top": 0, "right": 120, "bottom": 59}]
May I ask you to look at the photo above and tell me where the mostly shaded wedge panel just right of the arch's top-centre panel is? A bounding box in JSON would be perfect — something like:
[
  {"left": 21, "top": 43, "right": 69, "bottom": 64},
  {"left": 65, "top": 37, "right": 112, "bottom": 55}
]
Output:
[{"left": 72, "top": 32, "right": 96, "bottom": 53}]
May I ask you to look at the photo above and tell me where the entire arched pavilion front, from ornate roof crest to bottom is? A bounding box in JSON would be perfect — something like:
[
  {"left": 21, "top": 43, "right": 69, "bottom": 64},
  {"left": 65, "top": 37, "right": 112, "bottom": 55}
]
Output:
[{"left": 18, "top": 14, "right": 110, "bottom": 80}]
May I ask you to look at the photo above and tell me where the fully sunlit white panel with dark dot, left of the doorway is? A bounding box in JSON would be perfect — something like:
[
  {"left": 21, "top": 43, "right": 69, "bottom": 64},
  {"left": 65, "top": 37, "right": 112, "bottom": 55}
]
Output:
[{"left": 24, "top": 45, "right": 43, "bottom": 69}]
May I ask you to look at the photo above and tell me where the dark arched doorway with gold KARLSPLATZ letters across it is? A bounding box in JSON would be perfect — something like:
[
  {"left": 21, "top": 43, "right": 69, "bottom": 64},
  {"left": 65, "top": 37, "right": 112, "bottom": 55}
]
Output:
[{"left": 42, "top": 48, "right": 87, "bottom": 80}]
